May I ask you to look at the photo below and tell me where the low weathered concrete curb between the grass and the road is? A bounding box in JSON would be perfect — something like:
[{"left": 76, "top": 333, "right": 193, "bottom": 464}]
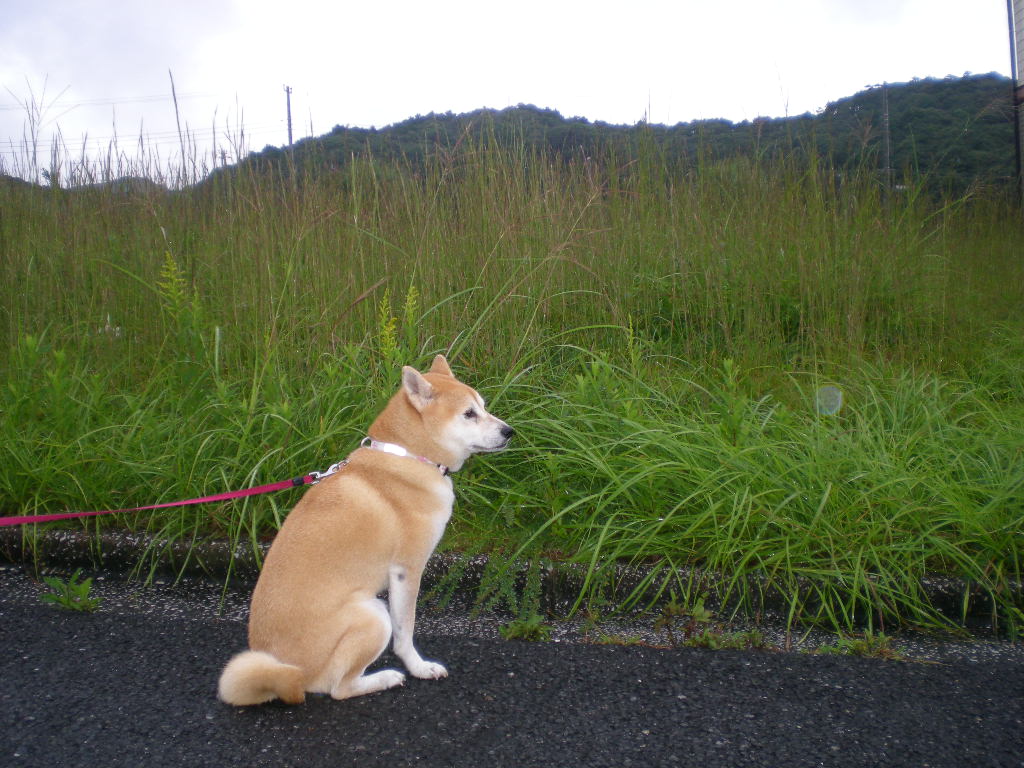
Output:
[{"left": 0, "top": 528, "right": 1024, "bottom": 635}]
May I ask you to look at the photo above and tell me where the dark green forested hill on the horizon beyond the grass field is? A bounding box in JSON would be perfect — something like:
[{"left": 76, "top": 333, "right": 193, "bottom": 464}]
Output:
[{"left": 248, "top": 73, "right": 1015, "bottom": 191}]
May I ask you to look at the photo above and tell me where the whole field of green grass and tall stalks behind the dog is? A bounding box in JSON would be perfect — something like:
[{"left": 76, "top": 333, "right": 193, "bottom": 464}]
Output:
[{"left": 0, "top": 131, "right": 1024, "bottom": 633}]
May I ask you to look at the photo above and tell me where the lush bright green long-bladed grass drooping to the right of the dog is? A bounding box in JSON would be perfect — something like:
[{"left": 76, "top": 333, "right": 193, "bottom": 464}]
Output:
[{"left": 479, "top": 352, "right": 1024, "bottom": 629}]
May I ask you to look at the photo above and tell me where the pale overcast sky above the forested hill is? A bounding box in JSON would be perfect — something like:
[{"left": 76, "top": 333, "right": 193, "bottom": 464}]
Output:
[{"left": 0, "top": 0, "right": 1010, "bottom": 176}]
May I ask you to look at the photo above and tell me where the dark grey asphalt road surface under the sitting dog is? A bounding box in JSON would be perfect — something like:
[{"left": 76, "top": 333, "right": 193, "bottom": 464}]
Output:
[{"left": 0, "top": 573, "right": 1024, "bottom": 768}]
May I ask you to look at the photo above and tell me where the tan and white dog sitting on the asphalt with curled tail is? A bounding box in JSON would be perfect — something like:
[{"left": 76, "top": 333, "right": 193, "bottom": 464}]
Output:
[{"left": 218, "top": 355, "right": 512, "bottom": 706}]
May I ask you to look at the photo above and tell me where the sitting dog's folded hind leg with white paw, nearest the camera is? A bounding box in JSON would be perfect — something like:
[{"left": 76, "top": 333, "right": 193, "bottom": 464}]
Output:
[{"left": 321, "top": 599, "right": 406, "bottom": 698}]
